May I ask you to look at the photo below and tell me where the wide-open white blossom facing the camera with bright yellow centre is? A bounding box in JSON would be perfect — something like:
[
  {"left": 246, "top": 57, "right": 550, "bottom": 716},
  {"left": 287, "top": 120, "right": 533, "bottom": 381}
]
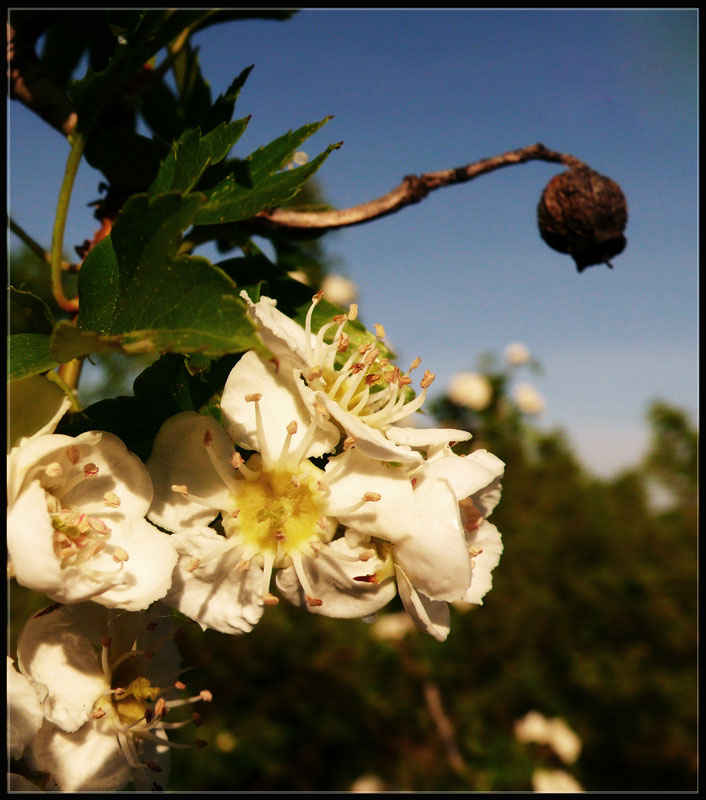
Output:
[{"left": 147, "top": 351, "right": 414, "bottom": 633}]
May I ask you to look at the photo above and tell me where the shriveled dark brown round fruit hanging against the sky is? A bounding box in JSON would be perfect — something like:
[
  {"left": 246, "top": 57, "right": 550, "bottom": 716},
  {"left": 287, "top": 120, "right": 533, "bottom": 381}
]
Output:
[{"left": 537, "top": 167, "right": 628, "bottom": 272}]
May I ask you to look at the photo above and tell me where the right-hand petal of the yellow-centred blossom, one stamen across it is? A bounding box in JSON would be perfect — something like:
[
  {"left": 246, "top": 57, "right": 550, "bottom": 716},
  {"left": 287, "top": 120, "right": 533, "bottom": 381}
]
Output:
[{"left": 326, "top": 447, "right": 415, "bottom": 542}]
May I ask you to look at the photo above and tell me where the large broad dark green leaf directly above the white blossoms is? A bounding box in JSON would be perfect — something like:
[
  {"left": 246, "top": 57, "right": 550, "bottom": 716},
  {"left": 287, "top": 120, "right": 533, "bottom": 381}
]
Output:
[{"left": 78, "top": 192, "right": 257, "bottom": 356}]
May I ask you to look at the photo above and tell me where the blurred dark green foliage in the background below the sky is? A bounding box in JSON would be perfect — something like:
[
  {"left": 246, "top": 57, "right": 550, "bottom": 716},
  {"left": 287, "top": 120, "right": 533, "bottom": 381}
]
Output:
[{"left": 11, "top": 360, "right": 697, "bottom": 792}]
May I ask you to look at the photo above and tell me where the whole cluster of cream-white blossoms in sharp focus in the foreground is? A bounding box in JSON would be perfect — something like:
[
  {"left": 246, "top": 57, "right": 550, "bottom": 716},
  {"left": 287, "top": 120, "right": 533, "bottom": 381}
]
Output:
[{"left": 8, "top": 292, "right": 504, "bottom": 791}]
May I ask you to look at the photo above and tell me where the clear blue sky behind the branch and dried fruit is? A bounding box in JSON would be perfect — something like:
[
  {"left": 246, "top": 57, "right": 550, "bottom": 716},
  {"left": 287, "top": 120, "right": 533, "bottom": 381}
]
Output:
[{"left": 9, "top": 9, "right": 699, "bottom": 475}]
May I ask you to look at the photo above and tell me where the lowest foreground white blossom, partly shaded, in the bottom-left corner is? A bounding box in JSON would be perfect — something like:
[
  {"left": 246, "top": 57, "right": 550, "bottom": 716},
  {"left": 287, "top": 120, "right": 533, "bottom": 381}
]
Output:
[{"left": 18, "top": 604, "right": 211, "bottom": 792}]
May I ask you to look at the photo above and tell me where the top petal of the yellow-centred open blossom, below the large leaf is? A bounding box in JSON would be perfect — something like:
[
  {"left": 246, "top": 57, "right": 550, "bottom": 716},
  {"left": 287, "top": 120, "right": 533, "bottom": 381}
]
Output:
[{"left": 221, "top": 350, "right": 340, "bottom": 458}]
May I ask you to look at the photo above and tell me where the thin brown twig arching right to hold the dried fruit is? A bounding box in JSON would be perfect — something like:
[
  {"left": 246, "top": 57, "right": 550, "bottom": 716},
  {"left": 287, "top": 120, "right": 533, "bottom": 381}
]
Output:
[{"left": 248, "top": 143, "right": 586, "bottom": 233}]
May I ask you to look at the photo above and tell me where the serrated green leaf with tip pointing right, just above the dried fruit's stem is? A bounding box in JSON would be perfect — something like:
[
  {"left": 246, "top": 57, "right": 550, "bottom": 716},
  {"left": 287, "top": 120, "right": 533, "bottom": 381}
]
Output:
[{"left": 195, "top": 144, "right": 339, "bottom": 225}]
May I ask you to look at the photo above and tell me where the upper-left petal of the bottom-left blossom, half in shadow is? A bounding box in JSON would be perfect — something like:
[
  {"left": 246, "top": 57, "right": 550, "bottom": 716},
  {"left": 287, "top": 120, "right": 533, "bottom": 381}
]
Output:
[{"left": 17, "top": 604, "right": 110, "bottom": 732}]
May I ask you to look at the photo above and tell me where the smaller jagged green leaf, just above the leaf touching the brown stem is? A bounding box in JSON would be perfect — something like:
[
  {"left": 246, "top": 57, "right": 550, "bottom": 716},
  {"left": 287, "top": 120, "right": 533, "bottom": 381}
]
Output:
[{"left": 148, "top": 118, "right": 249, "bottom": 197}]
